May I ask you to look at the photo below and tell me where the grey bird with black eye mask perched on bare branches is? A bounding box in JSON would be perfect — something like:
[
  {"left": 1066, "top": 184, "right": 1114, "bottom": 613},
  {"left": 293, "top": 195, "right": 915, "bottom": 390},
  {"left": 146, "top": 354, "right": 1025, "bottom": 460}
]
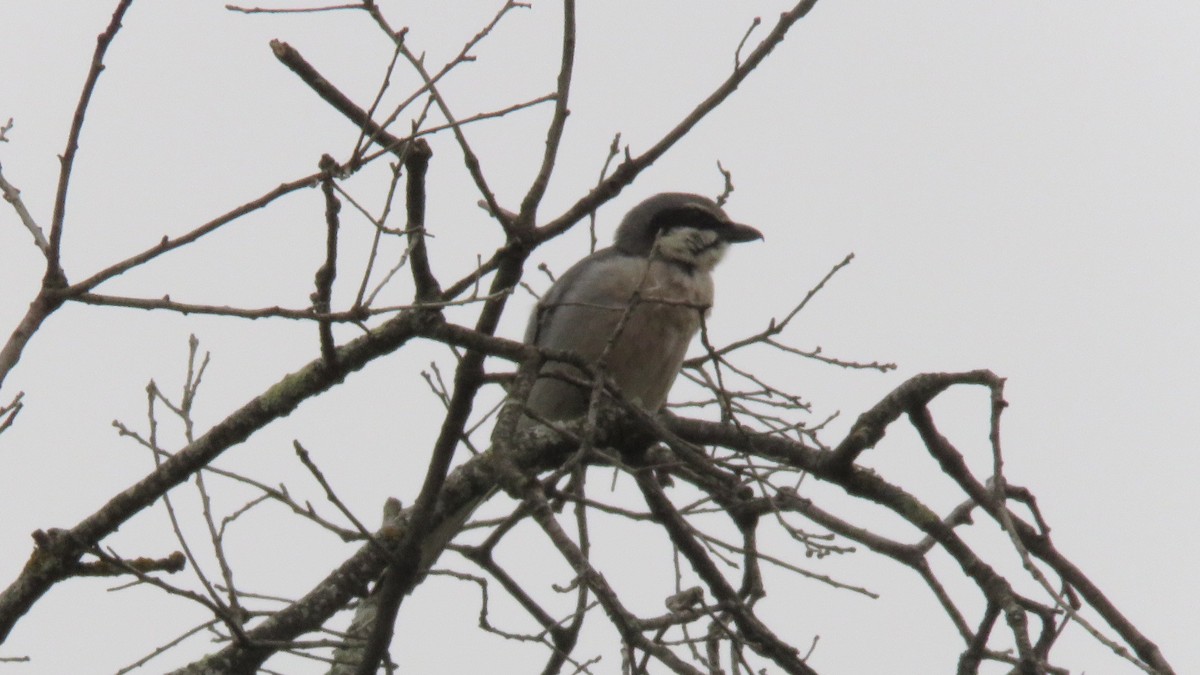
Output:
[{"left": 522, "top": 192, "right": 762, "bottom": 425}]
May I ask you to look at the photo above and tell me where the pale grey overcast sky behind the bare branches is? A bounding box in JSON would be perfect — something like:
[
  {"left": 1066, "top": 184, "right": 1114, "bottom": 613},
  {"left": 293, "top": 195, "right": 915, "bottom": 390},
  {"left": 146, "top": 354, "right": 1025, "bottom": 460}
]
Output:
[{"left": 0, "top": 0, "right": 1200, "bottom": 674}]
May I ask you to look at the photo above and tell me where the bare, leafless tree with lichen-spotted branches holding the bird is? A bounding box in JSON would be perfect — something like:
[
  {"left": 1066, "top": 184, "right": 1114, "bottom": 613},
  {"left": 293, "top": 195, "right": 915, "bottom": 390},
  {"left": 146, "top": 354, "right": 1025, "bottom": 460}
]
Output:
[{"left": 0, "top": 0, "right": 1172, "bottom": 674}]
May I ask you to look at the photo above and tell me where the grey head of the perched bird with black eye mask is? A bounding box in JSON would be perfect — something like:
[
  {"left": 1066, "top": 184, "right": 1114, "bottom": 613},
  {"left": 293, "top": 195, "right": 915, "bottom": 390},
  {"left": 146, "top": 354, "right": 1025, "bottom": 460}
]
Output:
[{"left": 613, "top": 192, "right": 762, "bottom": 271}]
